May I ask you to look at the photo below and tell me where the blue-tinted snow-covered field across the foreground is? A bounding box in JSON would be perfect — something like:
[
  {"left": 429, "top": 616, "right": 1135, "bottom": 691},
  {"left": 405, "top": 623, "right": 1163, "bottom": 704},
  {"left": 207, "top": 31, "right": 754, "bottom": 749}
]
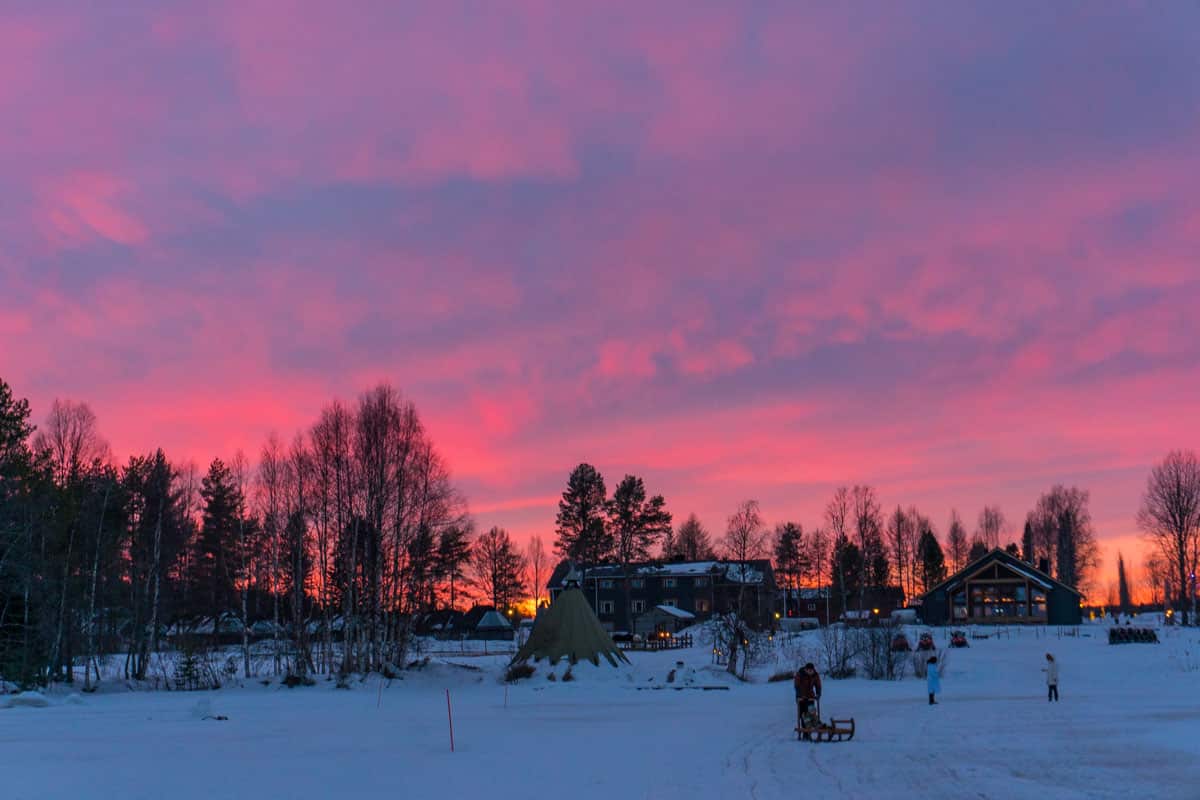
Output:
[{"left": 0, "top": 626, "right": 1200, "bottom": 800}]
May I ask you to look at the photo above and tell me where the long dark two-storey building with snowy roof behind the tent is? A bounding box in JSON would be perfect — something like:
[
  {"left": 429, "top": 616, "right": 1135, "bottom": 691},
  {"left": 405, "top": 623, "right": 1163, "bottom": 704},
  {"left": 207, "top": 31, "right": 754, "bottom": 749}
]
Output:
[{"left": 546, "top": 559, "right": 779, "bottom": 632}]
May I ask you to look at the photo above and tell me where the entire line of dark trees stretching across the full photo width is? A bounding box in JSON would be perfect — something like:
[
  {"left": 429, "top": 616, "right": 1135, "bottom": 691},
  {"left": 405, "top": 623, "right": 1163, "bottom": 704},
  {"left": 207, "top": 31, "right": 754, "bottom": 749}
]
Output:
[{"left": 0, "top": 371, "right": 1200, "bottom": 685}]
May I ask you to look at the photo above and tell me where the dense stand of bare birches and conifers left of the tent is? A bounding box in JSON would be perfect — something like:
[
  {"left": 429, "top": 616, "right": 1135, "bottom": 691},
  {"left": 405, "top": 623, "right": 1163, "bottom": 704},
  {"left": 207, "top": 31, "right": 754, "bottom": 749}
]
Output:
[{"left": 0, "top": 380, "right": 535, "bottom": 686}]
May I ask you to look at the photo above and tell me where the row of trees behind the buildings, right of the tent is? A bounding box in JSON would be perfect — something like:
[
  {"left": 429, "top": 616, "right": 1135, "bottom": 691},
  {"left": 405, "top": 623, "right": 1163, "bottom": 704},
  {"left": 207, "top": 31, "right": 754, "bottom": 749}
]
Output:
[{"left": 554, "top": 460, "right": 1200, "bottom": 628}]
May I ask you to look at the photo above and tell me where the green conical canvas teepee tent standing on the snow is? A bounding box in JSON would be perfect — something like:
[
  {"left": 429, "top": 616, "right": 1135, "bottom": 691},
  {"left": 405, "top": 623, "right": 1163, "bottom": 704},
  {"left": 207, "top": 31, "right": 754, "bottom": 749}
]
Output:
[{"left": 512, "top": 572, "right": 629, "bottom": 667}]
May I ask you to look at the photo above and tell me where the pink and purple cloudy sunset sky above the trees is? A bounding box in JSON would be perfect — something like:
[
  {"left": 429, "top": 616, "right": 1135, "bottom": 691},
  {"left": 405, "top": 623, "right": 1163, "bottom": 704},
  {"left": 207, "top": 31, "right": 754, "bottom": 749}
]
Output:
[{"left": 0, "top": 0, "right": 1200, "bottom": 597}]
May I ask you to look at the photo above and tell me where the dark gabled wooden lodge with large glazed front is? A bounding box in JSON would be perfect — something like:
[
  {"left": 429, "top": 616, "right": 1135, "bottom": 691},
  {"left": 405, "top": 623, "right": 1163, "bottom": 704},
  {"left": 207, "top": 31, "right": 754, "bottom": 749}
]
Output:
[{"left": 920, "top": 549, "right": 1082, "bottom": 625}]
